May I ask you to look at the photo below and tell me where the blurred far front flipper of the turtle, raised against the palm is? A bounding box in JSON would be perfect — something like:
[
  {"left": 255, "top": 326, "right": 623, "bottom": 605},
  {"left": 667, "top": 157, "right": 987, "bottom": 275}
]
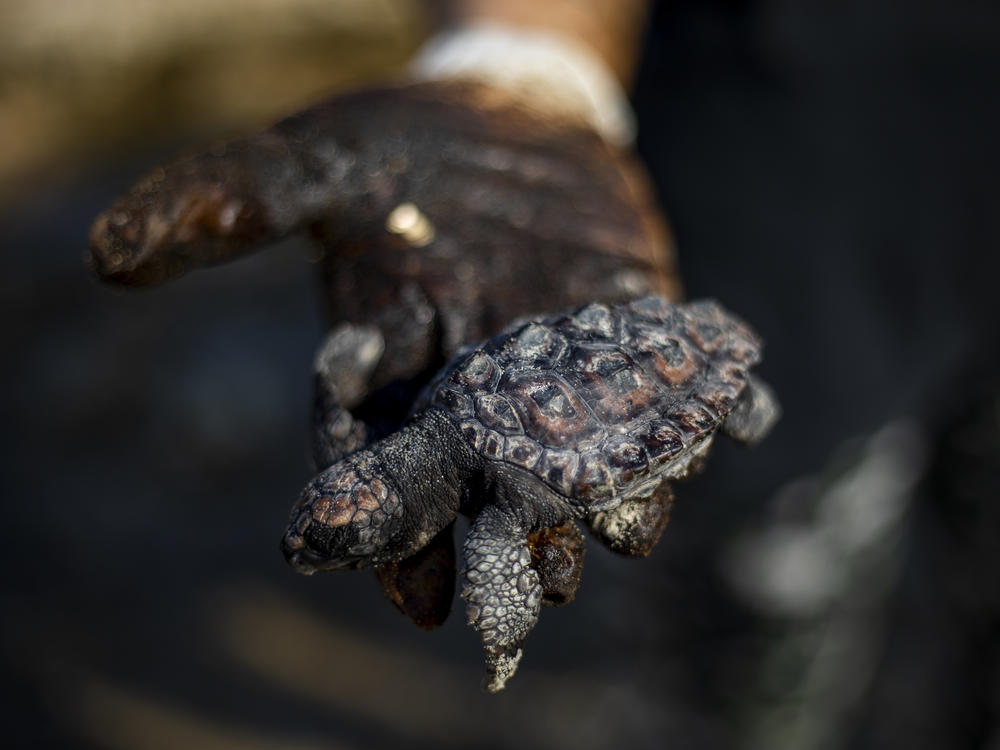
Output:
[{"left": 312, "top": 323, "right": 385, "bottom": 471}]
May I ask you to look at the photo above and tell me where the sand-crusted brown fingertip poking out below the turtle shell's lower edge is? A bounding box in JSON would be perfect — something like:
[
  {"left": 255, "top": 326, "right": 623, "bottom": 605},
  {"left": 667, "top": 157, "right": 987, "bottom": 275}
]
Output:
[{"left": 588, "top": 482, "right": 674, "bottom": 557}]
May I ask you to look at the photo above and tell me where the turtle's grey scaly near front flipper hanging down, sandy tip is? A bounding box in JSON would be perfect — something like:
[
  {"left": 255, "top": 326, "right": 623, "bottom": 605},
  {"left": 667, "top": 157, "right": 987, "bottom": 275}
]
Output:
[{"left": 462, "top": 505, "right": 542, "bottom": 693}]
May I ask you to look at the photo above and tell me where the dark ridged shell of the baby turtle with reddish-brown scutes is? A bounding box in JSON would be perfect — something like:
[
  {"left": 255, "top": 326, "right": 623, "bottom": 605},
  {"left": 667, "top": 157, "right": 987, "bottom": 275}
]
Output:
[{"left": 421, "top": 297, "right": 761, "bottom": 509}]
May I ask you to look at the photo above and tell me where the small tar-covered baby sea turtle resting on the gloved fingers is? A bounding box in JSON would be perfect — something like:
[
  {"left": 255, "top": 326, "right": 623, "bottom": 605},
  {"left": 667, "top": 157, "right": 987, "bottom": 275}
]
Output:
[{"left": 281, "top": 296, "right": 779, "bottom": 692}]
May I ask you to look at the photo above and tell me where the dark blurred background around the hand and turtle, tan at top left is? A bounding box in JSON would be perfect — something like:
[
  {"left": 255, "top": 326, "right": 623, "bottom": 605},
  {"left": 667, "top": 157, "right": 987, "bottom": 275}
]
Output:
[{"left": 0, "top": 0, "right": 1000, "bottom": 750}]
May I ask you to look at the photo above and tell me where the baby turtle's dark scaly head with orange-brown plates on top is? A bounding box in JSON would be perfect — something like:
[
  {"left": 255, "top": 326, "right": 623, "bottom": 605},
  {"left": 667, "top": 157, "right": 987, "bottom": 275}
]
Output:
[{"left": 281, "top": 451, "right": 403, "bottom": 574}]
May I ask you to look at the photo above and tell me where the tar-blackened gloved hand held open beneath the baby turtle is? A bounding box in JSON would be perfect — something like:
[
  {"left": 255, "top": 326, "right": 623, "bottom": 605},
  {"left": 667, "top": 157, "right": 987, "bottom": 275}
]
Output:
[{"left": 90, "top": 80, "right": 680, "bottom": 628}]
